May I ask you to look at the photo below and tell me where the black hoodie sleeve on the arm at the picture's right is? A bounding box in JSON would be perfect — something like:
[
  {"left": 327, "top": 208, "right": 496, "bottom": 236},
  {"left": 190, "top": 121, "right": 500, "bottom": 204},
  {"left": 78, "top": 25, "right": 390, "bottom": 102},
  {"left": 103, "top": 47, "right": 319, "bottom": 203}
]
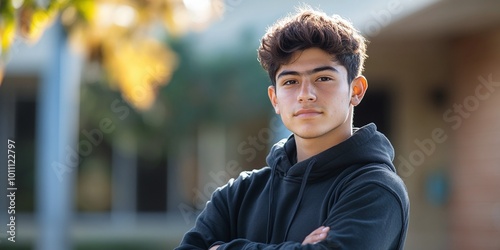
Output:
[{"left": 325, "top": 183, "right": 407, "bottom": 249}]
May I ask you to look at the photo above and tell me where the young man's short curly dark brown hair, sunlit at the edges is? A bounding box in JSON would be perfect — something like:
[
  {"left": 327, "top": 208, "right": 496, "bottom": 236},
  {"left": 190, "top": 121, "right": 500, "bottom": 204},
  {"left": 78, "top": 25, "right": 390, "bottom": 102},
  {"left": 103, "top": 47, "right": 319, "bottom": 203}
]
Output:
[{"left": 258, "top": 7, "right": 367, "bottom": 85}]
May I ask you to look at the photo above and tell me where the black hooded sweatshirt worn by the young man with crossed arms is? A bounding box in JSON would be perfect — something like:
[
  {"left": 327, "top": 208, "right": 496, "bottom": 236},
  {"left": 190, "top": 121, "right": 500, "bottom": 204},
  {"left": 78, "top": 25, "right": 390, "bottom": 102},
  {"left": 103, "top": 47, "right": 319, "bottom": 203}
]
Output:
[{"left": 177, "top": 124, "right": 409, "bottom": 250}]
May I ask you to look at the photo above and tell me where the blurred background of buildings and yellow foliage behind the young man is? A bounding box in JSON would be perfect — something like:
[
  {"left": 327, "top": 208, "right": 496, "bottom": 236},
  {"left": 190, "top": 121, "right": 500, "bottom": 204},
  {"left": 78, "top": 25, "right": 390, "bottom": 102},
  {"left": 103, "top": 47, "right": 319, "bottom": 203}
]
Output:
[{"left": 0, "top": 0, "right": 500, "bottom": 250}]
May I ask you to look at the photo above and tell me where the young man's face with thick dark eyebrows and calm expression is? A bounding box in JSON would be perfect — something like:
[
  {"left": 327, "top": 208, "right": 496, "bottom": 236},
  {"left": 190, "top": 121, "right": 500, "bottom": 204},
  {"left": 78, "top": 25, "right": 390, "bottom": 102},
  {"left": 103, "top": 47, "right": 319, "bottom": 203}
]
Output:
[{"left": 268, "top": 48, "right": 366, "bottom": 141}]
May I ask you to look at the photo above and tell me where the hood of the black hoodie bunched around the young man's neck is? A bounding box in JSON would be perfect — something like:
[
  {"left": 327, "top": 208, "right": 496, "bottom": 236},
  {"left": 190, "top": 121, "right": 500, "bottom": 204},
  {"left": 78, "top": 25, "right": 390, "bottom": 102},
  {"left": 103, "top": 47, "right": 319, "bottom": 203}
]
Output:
[{"left": 266, "top": 123, "right": 396, "bottom": 182}]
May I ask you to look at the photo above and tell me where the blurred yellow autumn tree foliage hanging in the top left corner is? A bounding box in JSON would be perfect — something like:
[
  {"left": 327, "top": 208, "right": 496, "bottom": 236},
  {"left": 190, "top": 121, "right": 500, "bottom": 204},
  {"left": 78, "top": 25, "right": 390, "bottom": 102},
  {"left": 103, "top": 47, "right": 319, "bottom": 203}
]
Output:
[{"left": 0, "top": 0, "right": 224, "bottom": 110}]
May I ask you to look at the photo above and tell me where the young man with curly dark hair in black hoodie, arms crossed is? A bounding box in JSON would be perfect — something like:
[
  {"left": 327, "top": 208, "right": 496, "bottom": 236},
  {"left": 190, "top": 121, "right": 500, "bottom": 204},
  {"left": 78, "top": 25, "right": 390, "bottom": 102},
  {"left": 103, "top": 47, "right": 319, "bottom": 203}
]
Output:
[{"left": 177, "top": 6, "right": 409, "bottom": 250}]
